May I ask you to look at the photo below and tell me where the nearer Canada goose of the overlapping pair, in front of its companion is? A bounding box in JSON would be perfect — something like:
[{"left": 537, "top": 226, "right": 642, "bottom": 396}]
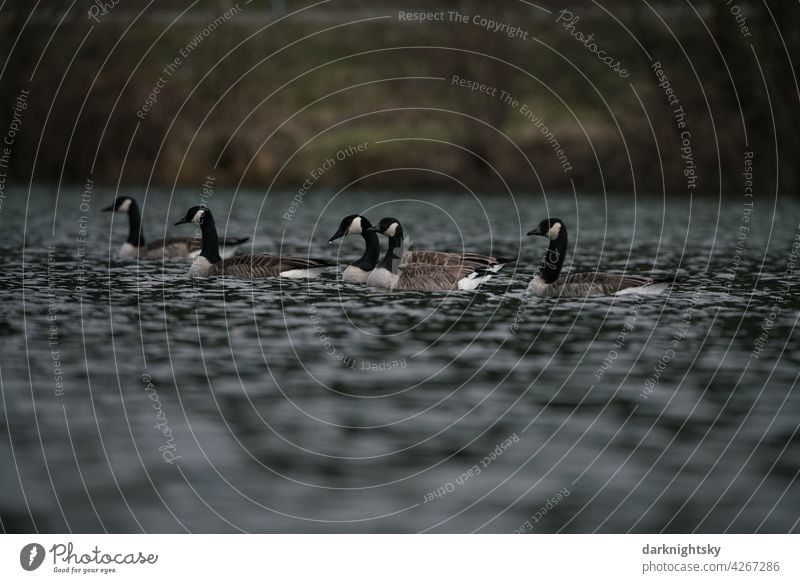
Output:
[{"left": 366, "top": 217, "right": 505, "bottom": 291}]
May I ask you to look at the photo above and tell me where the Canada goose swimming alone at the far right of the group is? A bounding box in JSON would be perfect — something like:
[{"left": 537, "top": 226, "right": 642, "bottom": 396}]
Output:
[{"left": 528, "top": 219, "right": 653, "bottom": 298}]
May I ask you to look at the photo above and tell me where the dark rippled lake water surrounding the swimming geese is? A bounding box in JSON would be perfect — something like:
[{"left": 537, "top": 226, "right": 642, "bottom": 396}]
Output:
[{"left": 0, "top": 187, "right": 800, "bottom": 532}]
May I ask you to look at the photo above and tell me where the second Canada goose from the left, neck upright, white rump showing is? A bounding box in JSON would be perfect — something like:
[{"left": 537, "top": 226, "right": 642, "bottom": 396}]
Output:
[{"left": 175, "top": 206, "right": 336, "bottom": 278}]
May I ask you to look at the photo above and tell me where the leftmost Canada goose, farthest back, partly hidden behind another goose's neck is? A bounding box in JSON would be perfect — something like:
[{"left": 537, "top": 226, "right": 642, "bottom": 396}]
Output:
[{"left": 103, "top": 196, "right": 250, "bottom": 259}]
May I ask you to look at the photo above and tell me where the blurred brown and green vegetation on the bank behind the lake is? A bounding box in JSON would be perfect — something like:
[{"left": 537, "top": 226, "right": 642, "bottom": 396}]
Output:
[{"left": 0, "top": 0, "right": 800, "bottom": 196}]
